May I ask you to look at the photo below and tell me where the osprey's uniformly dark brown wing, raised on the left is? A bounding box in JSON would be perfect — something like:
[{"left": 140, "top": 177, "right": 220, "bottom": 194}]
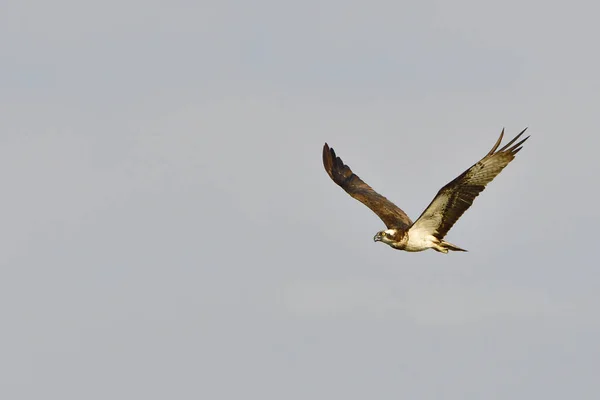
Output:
[{"left": 323, "top": 143, "right": 412, "bottom": 230}]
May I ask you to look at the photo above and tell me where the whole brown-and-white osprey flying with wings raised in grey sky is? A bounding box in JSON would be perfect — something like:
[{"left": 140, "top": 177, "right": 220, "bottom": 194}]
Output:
[{"left": 323, "top": 128, "right": 529, "bottom": 253}]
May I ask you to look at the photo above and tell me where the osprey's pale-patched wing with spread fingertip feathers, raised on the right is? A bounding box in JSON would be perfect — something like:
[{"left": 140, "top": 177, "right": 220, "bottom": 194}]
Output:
[{"left": 409, "top": 128, "right": 529, "bottom": 240}]
